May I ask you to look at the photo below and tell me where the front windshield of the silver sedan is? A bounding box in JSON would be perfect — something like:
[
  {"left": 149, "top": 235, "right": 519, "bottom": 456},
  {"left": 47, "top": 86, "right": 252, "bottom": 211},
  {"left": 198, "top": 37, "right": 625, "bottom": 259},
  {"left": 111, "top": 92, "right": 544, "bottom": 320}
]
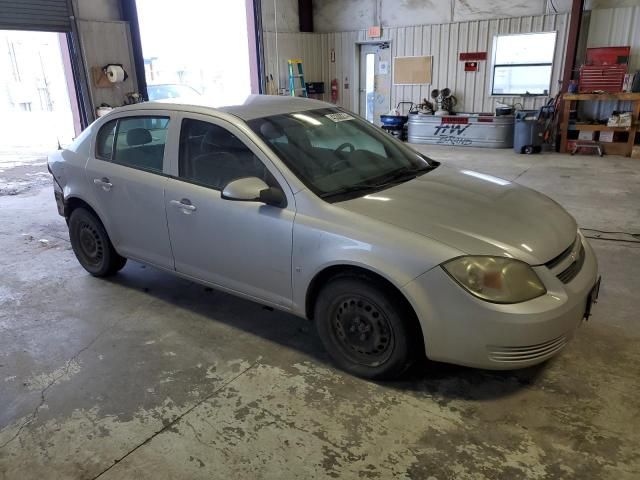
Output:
[{"left": 248, "top": 108, "right": 439, "bottom": 202}]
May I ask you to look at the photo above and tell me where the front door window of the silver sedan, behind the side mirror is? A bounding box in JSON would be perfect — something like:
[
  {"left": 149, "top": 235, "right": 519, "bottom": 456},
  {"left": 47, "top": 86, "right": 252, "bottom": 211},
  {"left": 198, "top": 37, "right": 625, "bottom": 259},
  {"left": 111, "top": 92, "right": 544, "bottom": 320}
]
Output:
[{"left": 178, "top": 119, "right": 275, "bottom": 190}]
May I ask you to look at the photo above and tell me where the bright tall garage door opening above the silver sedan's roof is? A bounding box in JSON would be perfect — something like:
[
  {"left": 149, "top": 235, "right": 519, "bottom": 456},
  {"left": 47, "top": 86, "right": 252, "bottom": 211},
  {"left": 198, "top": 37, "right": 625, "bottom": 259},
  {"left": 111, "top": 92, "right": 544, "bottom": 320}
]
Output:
[{"left": 136, "top": 0, "right": 251, "bottom": 105}]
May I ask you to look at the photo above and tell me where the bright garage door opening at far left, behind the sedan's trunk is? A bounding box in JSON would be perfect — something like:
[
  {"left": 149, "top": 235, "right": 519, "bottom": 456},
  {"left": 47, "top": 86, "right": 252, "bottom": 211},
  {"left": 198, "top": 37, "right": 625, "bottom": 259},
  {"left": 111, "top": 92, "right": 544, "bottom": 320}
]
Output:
[{"left": 0, "top": 30, "right": 81, "bottom": 196}]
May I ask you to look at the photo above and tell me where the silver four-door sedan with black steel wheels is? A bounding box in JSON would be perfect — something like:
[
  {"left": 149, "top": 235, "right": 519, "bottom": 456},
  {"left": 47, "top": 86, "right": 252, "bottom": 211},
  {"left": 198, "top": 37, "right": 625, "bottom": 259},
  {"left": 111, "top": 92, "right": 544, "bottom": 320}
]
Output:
[{"left": 49, "top": 96, "right": 599, "bottom": 378}]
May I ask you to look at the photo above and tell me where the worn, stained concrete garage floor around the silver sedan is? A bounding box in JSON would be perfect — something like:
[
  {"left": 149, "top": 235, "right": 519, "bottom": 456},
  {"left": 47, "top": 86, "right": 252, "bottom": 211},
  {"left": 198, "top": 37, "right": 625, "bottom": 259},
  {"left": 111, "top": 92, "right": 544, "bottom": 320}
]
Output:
[{"left": 0, "top": 147, "right": 640, "bottom": 480}]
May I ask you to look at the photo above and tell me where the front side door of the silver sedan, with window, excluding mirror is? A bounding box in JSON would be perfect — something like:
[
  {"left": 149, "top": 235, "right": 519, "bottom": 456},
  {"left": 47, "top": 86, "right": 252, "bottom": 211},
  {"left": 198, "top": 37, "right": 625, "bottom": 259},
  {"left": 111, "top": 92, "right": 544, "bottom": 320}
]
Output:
[{"left": 165, "top": 115, "right": 295, "bottom": 307}]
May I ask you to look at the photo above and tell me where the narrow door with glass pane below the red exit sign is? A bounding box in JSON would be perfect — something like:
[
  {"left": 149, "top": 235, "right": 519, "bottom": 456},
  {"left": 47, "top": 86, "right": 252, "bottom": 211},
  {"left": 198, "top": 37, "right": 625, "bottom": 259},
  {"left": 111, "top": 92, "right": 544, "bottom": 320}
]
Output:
[{"left": 358, "top": 42, "right": 391, "bottom": 124}]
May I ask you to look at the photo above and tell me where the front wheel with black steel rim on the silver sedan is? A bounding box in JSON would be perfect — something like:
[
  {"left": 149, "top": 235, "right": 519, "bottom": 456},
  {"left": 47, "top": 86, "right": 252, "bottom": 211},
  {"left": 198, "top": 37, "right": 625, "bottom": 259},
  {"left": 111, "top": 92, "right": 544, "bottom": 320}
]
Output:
[{"left": 314, "top": 277, "right": 422, "bottom": 379}]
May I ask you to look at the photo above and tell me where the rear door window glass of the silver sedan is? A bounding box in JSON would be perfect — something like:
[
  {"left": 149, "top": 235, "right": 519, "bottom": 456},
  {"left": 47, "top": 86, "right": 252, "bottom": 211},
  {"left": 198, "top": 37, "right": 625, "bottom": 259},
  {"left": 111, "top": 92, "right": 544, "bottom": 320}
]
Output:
[{"left": 112, "top": 117, "right": 169, "bottom": 173}]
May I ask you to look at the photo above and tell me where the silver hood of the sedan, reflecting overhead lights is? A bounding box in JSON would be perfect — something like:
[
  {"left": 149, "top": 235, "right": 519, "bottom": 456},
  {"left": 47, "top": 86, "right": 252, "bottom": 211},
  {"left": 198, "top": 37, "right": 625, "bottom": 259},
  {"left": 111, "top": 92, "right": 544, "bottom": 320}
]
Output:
[{"left": 336, "top": 166, "right": 577, "bottom": 265}]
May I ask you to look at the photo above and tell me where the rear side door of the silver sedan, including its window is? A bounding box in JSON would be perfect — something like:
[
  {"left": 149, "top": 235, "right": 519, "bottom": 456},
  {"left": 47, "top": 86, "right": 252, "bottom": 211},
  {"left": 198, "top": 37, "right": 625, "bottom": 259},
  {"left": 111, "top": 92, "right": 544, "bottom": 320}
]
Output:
[{"left": 86, "top": 113, "right": 173, "bottom": 269}]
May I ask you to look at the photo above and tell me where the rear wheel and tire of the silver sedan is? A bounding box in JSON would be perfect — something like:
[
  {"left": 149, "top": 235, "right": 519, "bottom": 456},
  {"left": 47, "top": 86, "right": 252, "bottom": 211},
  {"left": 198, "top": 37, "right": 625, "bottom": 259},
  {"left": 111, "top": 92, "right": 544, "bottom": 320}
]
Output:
[{"left": 69, "top": 207, "right": 127, "bottom": 277}]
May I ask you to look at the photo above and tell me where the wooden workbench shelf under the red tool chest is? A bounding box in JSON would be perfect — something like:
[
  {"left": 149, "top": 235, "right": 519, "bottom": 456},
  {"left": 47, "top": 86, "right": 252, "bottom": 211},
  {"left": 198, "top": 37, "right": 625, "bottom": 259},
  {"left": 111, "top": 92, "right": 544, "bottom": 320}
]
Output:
[{"left": 560, "top": 93, "right": 640, "bottom": 157}]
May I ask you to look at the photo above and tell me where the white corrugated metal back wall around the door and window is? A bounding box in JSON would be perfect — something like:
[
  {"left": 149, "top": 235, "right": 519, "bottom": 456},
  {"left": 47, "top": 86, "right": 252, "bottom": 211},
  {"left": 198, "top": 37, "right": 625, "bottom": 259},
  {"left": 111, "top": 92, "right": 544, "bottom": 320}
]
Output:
[{"left": 265, "top": 14, "right": 569, "bottom": 112}]
